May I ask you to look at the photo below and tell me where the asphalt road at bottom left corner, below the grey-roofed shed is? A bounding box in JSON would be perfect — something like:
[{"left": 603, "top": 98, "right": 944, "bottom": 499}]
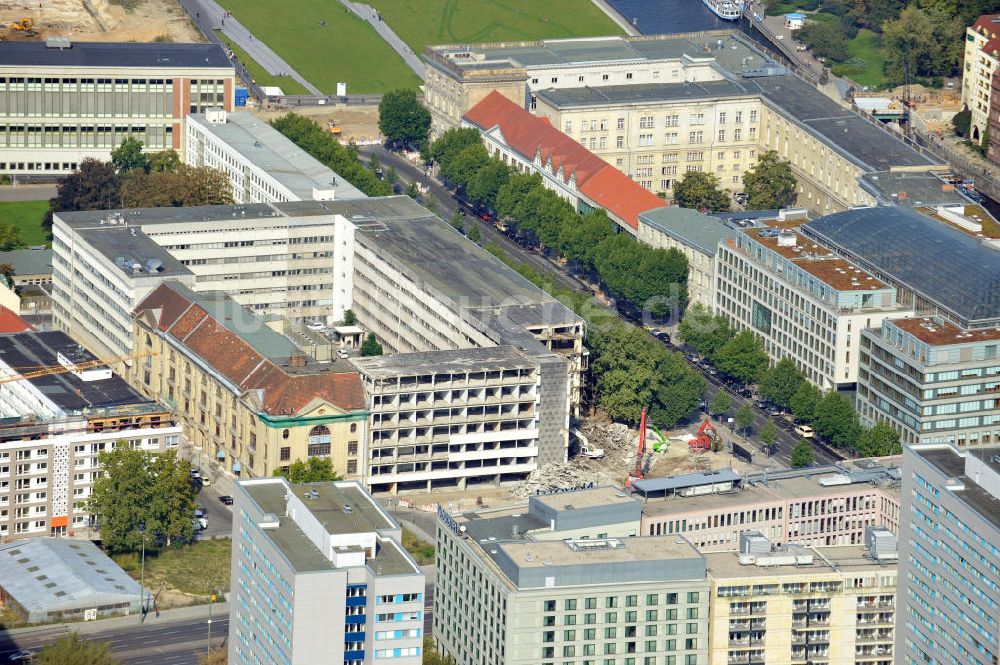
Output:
[{"left": 0, "top": 614, "right": 229, "bottom": 665}]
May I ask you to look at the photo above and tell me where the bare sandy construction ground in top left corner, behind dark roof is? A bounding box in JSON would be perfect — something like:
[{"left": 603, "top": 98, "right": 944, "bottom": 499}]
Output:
[{"left": 0, "top": 0, "right": 204, "bottom": 42}]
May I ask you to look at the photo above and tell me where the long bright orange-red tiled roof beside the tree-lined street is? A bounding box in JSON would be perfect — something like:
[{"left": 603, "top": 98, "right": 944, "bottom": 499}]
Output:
[{"left": 464, "top": 91, "right": 666, "bottom": 229}]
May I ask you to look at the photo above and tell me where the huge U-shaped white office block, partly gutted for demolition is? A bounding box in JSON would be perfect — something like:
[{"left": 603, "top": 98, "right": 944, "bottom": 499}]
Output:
[{"left": 53, "top": 196, "right": 587, "bottom": 491}]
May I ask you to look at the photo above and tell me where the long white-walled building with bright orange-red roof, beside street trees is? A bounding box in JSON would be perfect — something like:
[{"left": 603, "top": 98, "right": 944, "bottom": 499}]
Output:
[{"left": 463, "top": 91, "right": 666, "bottom": 234}]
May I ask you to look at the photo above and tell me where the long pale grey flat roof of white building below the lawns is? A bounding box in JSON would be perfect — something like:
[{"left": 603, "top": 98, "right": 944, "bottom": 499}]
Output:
[{"left": 189, "top": 111, "right": 365, "bottom": 200}]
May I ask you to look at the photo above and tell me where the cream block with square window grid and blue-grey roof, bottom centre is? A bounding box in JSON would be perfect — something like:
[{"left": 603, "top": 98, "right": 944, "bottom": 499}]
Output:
[{"left": 434, "top": 487, "right": 708, "bottom": 665}]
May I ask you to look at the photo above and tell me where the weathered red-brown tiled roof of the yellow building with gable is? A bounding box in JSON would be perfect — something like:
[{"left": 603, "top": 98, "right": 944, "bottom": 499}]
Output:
[{"left": 136, "top": 284, "right": 365, "bottom": 416}]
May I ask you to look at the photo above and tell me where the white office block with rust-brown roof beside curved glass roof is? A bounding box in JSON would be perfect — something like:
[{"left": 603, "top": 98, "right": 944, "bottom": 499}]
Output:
[{"left": 715, "top": 227, "right": 913, "bottom": 390}]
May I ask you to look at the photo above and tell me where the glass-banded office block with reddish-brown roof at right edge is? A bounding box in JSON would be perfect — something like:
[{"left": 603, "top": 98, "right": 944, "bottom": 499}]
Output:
[{"left": 857, "top": 317, "right": 1000, "bottom": 446}]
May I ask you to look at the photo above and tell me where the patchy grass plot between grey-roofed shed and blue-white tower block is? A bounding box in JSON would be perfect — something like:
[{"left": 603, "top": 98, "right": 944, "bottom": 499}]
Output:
[{"left": 140, "top": 538, "right": 233, "bottom": 596}]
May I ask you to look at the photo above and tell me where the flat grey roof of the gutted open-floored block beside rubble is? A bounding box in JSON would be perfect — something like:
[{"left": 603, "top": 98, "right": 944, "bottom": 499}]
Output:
[{"left": 351, "top": 345, "right": 536, "bottom": 378}]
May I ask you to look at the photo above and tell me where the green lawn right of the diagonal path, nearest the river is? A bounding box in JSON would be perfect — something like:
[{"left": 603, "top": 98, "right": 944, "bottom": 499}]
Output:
[{"left": 371, "top": 0, "right": 622, "bottom": 53}]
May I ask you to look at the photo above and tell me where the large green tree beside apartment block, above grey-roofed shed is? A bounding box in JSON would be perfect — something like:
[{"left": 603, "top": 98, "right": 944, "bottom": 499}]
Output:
[{"left": 87, "top": 442, "right": 194, "bottom": 553}]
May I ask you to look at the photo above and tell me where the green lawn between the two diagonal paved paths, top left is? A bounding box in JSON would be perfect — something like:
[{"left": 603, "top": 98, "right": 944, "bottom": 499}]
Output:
[{"left": 226, "top": 0, "right": 420, "bottom": 94}]
